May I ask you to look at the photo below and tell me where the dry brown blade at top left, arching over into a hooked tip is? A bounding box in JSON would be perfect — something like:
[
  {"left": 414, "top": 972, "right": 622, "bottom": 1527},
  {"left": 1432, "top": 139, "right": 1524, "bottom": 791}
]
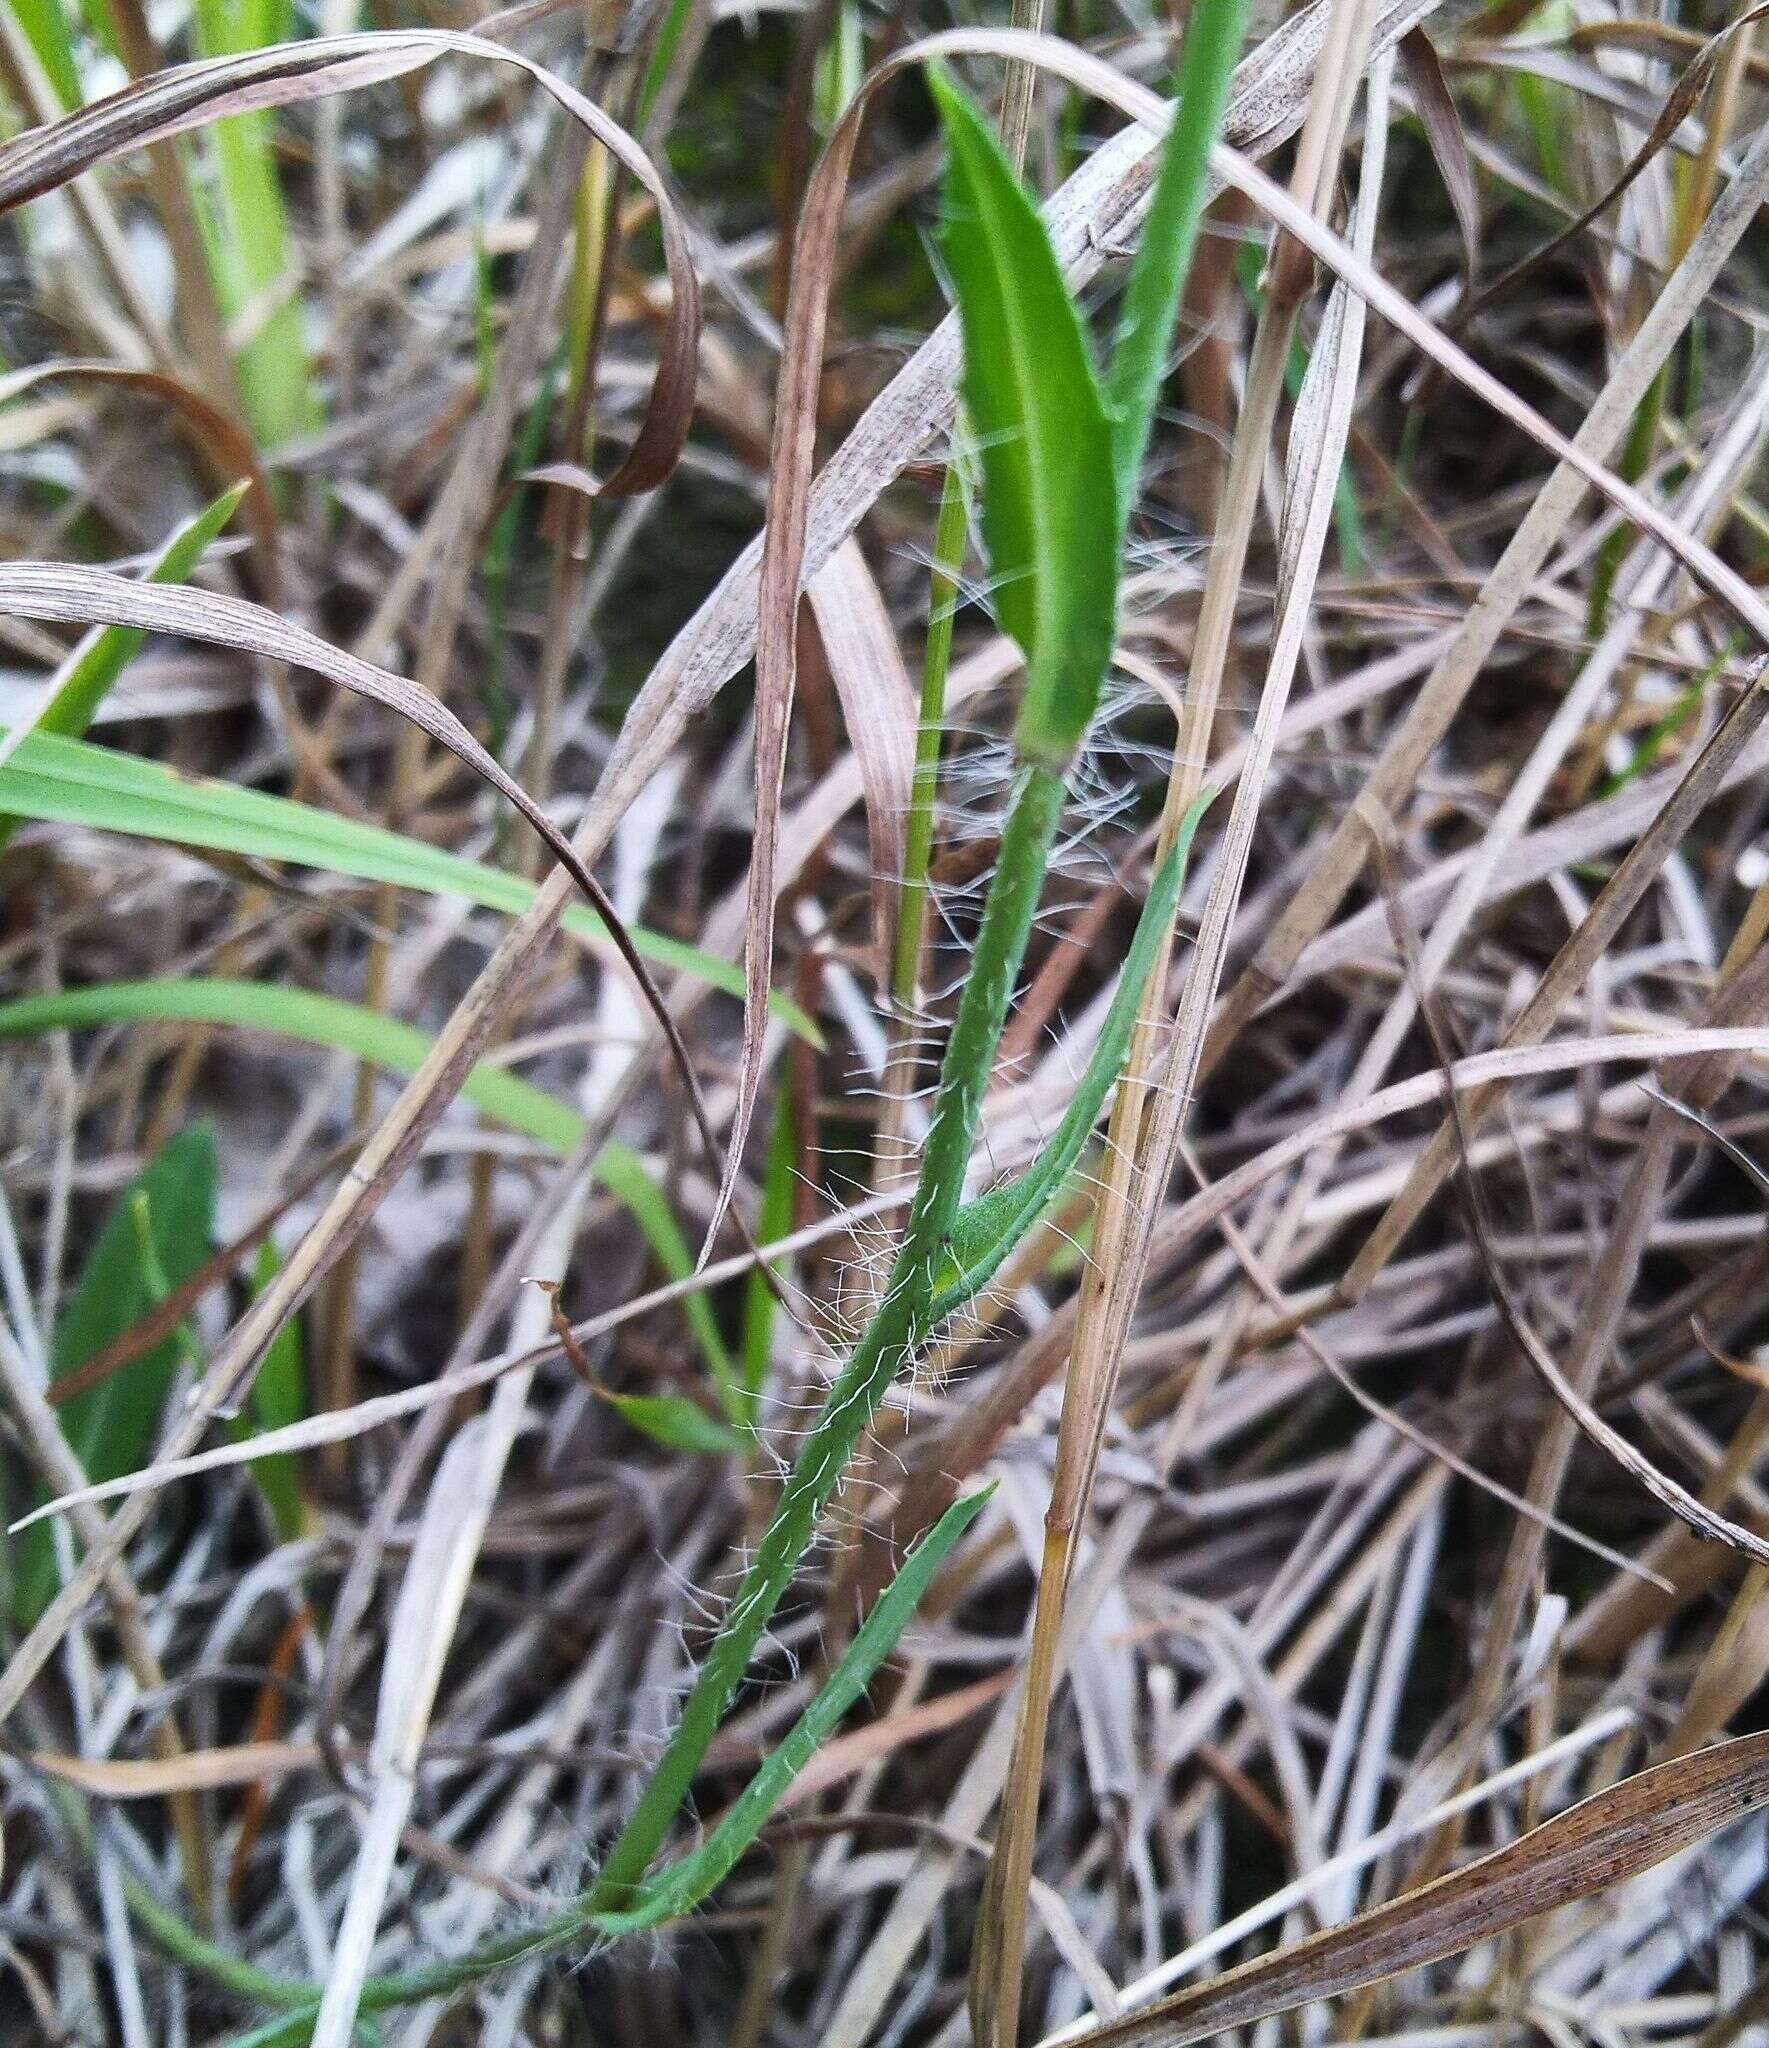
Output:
[{"left": 0, "top": 29, "right": 700, "bottom": 496}]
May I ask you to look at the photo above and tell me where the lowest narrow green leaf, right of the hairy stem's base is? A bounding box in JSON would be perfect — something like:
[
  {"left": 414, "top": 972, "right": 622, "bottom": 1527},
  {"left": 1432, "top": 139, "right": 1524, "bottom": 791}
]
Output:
[{"left": 590, "top": 1487, "right": 995, "bottom": 1933}]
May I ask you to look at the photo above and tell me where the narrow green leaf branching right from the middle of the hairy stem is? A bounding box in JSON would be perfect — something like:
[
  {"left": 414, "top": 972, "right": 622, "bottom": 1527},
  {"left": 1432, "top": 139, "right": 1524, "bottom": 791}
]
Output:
[{"left": 936, "top": 791, "right": 1216, "bottom": 1319}]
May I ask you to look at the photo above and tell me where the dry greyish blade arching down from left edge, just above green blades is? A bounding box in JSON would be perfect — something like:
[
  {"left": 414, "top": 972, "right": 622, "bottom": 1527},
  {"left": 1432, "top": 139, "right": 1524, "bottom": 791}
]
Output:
[{"left": 0, "top": 561, "right": 728, "bottom": 1196}]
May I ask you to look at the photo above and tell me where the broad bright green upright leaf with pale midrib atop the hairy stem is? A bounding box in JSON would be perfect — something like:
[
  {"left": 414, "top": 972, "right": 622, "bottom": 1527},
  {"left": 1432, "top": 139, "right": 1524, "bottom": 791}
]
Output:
[{"left": 927, "top": 68, "right": 1118, "bottom": 772}]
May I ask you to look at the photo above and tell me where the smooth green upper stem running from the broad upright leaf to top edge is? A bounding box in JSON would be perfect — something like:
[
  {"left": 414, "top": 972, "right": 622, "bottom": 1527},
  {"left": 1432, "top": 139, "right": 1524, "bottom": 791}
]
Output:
[{"left": 1106, "top": 0, "right": 1247, "bottom": 516}]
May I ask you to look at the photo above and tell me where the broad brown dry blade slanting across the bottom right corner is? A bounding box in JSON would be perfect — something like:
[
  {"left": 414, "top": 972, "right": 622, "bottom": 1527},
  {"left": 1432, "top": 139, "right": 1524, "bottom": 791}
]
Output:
[{"left": 1077, "top": 1735, "right": 1769, "bottom": 2048}]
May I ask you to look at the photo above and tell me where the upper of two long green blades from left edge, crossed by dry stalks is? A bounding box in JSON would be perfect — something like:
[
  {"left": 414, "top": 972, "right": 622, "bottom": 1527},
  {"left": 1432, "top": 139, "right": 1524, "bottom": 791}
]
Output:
[{"left": 0, "top": 733, "right": 821, "bottom": 1044}]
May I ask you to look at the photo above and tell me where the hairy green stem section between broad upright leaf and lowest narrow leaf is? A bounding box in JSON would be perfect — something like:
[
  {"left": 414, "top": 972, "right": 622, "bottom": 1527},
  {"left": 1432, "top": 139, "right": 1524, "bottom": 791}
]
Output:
[{"left": 590, "top": 768, "right": 1065, "bottom": 1911}]
